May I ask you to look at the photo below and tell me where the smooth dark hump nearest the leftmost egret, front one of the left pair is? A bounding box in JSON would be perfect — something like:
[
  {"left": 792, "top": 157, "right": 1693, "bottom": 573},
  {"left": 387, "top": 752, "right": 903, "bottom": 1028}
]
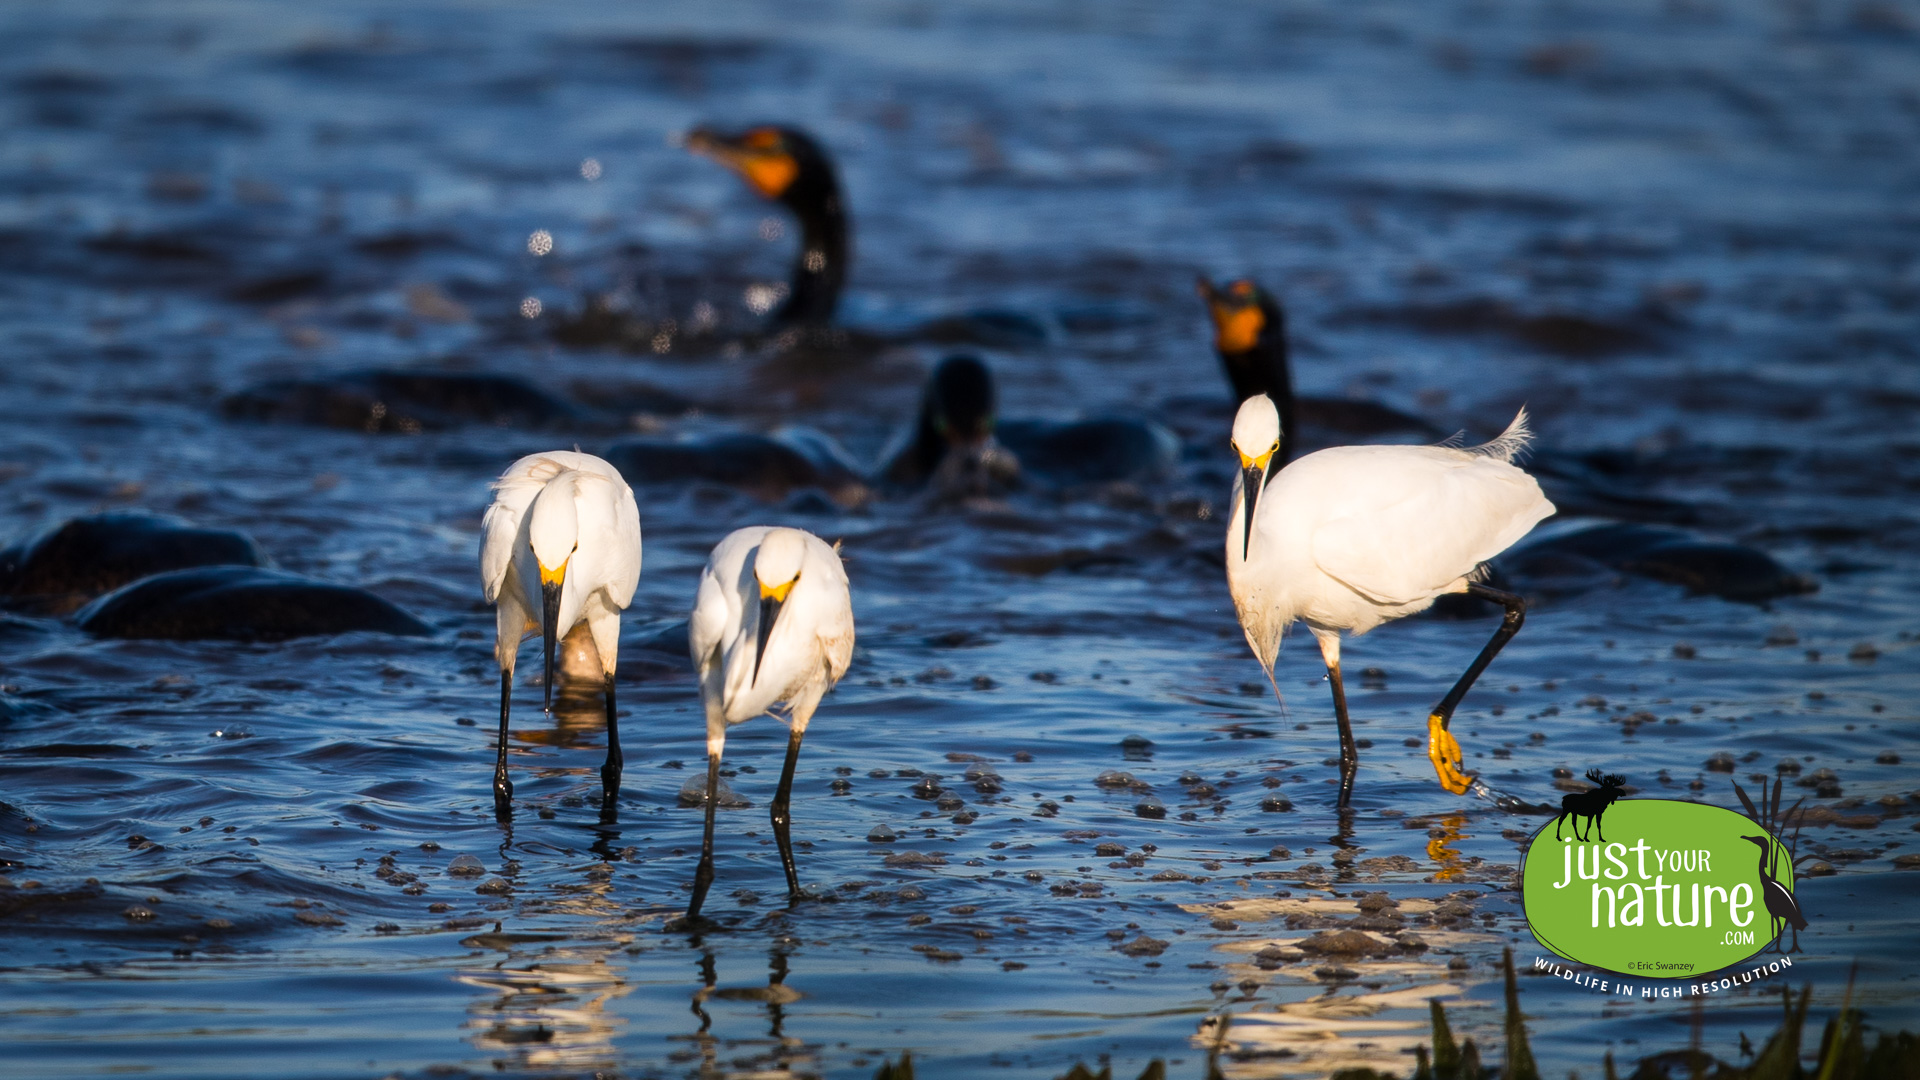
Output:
[{"left": 79, "top": 567, "right": 434, "bottom": 642}]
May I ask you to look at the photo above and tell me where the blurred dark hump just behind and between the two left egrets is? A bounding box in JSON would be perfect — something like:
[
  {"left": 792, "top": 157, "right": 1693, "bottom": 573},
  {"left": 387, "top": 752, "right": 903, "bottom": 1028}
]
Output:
[{"left": 605, "top": 429, "right": 868, "bottom": 507}]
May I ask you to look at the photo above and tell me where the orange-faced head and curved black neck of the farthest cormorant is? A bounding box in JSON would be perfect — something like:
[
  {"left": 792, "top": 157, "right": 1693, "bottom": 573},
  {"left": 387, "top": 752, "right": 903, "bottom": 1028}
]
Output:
[{"left": 685, "top": 125, "right": 851, "bottom": 325}]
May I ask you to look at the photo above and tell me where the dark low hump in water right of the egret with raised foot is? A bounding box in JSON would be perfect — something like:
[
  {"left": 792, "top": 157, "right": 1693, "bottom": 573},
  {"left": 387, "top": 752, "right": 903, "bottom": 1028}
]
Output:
[{"left": 1496, "top": 521, "right": 1820, "bottom": 603}]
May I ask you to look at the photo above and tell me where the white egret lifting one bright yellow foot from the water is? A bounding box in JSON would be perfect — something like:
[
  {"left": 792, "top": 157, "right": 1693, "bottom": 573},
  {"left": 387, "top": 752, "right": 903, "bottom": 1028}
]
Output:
[{"left": 1227, "top": 394, "right": 1553, "bottom": 807}]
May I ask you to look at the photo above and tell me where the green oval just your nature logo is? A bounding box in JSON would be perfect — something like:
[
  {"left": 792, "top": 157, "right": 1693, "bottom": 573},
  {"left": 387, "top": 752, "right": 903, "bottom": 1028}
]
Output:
[{"left": 1521, "top": 799, "right": 1793, "bottom": 978}]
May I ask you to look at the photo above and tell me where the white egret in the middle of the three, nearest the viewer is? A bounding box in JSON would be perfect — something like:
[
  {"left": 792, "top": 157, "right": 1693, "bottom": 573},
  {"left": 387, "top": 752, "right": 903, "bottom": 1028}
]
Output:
[{"left": 687, "top": 525, "right": 852, "bottom": 920}]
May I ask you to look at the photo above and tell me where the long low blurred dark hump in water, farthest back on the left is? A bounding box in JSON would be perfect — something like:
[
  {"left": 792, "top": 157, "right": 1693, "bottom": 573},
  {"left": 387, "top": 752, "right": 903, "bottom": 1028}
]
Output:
[{"left": 221, "top": 371, "right": 589, "bottom": 434}]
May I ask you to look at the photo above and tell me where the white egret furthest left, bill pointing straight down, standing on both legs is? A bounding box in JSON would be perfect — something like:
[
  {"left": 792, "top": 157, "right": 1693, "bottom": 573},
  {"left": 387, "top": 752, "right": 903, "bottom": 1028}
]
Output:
[{"left": 480, "top": 450, "right": 639, "bottom": 817}]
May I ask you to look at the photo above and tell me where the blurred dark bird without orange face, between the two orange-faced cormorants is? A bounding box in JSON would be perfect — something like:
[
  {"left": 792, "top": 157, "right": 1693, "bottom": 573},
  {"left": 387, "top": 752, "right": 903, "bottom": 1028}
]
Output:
[{"left": 877, "top": 354, "right": 1179, "bottom": 496}]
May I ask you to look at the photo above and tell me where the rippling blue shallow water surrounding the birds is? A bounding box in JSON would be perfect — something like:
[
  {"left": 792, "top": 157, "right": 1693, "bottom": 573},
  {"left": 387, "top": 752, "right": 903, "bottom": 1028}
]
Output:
[{"left": 0, "top": 0, "right": 1920, "bottom": 1076}]
